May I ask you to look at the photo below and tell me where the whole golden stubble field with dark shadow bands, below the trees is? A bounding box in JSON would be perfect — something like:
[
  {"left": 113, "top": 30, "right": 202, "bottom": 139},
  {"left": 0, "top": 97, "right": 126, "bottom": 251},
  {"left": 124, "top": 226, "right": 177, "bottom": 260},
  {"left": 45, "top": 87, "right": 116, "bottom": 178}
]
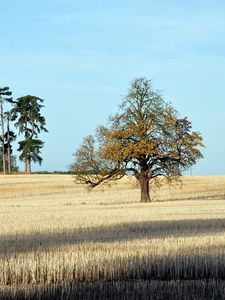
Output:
[{"left": 0, "top": 175, "right": 225, "bottom": 299}]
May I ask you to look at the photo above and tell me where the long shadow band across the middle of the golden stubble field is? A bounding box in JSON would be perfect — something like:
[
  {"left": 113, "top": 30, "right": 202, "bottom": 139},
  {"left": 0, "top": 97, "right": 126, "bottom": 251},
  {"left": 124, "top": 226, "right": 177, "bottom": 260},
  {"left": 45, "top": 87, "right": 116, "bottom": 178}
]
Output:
[{"left": 0, "top": 219, "right": 225, "bottom": 254}]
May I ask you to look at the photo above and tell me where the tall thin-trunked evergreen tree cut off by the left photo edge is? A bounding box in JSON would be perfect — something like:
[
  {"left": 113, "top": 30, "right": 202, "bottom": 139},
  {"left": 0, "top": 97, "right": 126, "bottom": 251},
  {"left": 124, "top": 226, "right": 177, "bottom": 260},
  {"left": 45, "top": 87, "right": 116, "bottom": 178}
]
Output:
[{"left": 0, "top": 86, "right": 12, "bottom": 173}]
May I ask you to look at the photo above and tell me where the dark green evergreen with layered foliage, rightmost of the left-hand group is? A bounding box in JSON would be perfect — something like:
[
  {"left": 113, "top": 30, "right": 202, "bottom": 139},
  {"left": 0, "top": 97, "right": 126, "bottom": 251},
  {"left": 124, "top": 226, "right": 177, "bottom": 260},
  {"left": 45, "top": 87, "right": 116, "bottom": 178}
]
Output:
[{"left": 12, "top": 95, "right": 48, "bottom": 173}]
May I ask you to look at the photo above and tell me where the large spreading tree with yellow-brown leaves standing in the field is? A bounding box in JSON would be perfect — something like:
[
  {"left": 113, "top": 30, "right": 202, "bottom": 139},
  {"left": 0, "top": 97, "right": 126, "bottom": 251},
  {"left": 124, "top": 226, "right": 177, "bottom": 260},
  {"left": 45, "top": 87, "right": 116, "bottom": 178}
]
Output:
[{"left": 72, "top": 78, "right": 203, "bottom": 202}]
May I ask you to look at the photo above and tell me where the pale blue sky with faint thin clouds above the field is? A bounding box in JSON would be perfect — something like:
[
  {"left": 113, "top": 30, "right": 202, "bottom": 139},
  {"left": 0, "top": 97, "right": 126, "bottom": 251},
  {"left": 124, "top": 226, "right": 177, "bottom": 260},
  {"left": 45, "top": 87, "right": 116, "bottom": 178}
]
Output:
[{"left": 0, "top": 0, "right": 225, "bottom": 175}]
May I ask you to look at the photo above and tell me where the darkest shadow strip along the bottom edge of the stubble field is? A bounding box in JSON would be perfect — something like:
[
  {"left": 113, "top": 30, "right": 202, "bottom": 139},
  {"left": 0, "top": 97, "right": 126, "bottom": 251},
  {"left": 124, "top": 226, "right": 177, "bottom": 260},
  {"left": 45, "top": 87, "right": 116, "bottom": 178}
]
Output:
[{"left": 1, "top": 280, "right": 225, "bottom": 300}]
